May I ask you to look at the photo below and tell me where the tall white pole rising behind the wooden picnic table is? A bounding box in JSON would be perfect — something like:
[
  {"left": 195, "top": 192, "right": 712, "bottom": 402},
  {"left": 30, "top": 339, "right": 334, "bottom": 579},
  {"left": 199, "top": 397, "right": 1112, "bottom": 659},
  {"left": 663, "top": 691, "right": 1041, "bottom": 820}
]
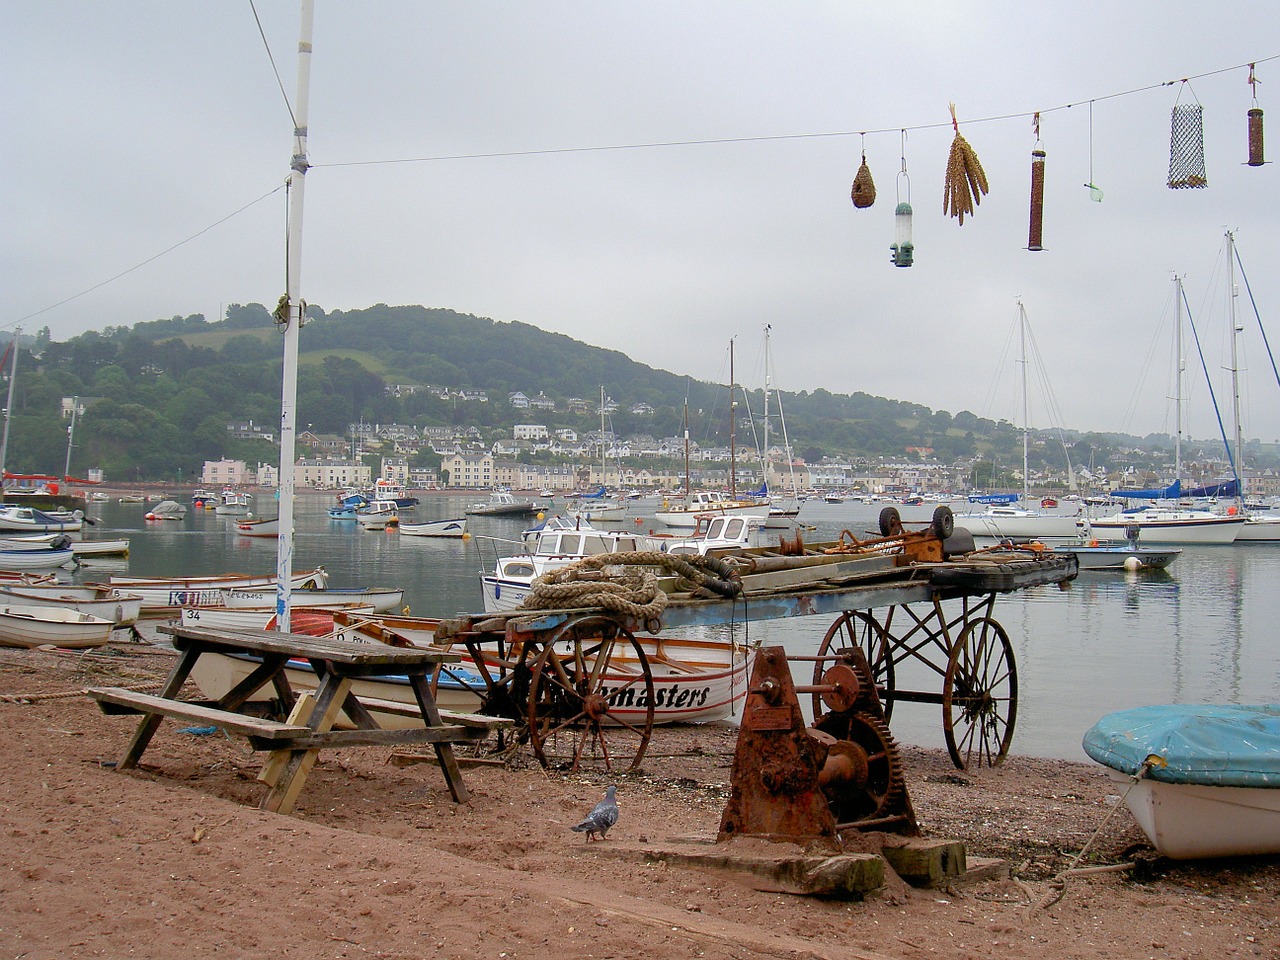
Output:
[{"left": 275, "top": 0, "right": 315, "bottom": 630}]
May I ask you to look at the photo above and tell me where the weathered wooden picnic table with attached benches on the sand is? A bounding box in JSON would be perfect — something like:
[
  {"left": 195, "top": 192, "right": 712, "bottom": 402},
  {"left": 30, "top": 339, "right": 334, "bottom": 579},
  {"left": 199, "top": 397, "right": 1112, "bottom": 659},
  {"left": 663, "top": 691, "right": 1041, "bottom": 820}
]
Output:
[{"left": 88, "top": 626, "right": 511, "bottom": 813}]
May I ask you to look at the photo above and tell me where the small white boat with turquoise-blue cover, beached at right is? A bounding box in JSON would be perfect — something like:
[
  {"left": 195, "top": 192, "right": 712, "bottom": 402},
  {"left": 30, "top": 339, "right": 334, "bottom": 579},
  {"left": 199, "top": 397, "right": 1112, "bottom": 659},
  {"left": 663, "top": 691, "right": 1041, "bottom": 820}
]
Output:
[{"left": 1083, "top": 704, "right": 1280, "bottom": 860}]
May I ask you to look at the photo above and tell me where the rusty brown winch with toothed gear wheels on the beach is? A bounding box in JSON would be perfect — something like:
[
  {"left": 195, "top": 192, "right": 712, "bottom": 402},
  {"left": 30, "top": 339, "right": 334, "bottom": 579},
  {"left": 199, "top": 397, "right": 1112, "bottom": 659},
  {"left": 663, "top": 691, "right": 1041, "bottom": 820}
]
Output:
[{"left": 719, "top": 646, "right": 919, "bottom": 847}]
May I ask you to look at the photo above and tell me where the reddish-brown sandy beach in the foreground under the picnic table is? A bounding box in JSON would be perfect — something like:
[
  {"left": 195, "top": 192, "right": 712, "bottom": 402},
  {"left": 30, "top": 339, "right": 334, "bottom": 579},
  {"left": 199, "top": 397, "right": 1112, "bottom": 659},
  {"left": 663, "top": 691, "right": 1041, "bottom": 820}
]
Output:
[{"left": 0, "top": 644, "right": 1280, "bottom": 960}]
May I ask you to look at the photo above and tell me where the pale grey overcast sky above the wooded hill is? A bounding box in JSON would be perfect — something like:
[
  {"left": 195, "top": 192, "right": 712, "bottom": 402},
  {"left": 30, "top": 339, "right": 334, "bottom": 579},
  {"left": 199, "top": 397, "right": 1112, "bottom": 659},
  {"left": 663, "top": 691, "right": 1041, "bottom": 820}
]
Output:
[{"left": 0, "top": 0, "right": 1280, "bottom": 440}]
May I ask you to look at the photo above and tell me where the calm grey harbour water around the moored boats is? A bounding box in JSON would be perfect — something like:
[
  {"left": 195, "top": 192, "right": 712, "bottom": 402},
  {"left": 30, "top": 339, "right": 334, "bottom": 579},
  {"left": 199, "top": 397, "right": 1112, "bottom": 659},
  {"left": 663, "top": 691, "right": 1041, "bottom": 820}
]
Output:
[{"left": 78, "top": 494, "right": 1280, "bottom": 759}]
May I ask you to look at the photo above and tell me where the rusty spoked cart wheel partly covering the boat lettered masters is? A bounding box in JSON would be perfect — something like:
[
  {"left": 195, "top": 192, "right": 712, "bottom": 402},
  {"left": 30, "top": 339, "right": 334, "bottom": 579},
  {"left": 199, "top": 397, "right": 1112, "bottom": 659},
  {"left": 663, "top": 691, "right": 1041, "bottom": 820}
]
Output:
[{"left": 527, "top": 616, "right": 654, "bottom": 771}]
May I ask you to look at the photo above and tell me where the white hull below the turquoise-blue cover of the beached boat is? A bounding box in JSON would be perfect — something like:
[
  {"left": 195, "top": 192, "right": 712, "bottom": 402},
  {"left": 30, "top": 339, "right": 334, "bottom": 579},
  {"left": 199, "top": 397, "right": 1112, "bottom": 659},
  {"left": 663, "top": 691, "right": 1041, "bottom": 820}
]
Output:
[{"left": 1106, "top": 767, "right": 1280, "bottom": 860}]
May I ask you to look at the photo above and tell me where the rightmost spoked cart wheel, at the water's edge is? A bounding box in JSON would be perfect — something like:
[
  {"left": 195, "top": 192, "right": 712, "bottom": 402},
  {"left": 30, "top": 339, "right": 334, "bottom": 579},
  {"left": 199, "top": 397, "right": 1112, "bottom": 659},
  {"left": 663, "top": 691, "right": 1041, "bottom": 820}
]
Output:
[{"left": 942, "top": 617, "right": 1018, "bottom": 769}]
